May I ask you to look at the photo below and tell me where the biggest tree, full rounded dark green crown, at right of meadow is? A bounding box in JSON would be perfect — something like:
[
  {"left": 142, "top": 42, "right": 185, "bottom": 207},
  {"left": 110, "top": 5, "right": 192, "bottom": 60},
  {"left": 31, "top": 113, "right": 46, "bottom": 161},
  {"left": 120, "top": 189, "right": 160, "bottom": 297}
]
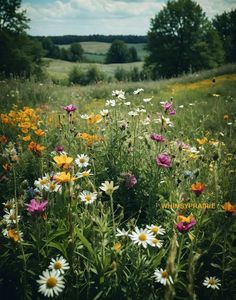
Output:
[{"left": 145, "top": 0, "right": 224, "bottom": 79}]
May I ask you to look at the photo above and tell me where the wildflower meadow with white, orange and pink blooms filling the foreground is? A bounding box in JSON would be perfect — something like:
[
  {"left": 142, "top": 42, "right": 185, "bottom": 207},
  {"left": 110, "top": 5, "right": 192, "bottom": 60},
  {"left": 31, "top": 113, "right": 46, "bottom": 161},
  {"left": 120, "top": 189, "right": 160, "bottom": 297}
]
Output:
[{"left": 0, "top": 67, "right": 236, "bottom": 300}]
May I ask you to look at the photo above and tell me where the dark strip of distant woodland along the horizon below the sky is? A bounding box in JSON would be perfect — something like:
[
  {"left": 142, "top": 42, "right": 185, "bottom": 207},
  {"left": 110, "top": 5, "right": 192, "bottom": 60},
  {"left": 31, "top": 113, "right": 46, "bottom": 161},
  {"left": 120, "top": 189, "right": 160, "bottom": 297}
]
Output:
[{"left": 34, "top": 34, "right": 147, "bottom": 45}]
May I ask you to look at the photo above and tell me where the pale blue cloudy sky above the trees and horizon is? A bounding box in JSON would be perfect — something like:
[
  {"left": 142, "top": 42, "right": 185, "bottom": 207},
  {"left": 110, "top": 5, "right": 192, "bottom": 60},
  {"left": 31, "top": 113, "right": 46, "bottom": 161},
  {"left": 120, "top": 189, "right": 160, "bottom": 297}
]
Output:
[{"left": 22, "top": 0, "right": 236, "bottom": 35}]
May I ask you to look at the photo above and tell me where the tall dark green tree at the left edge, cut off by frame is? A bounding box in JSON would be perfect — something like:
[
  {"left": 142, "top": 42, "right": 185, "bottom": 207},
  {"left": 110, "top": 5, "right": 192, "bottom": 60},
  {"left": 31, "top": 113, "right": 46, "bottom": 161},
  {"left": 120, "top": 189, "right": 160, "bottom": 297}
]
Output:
[{"left": 0, "top": 0, "right": 43, "bottom": 77}]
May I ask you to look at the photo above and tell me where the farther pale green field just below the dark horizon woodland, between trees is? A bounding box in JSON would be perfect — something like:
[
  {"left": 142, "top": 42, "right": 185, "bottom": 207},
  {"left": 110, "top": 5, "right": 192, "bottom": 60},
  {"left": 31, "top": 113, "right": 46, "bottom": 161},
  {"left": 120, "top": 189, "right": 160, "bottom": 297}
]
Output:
[{"left": 59, "top": 42, "right": 147, "bottom": 63}]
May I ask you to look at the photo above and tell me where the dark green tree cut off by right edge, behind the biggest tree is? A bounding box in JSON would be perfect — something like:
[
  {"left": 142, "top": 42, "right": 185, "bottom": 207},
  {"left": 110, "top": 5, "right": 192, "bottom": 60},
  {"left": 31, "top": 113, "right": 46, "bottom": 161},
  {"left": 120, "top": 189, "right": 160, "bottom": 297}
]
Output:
[{"left": 213, "top": 9, "right": 236, "bottom": 62}]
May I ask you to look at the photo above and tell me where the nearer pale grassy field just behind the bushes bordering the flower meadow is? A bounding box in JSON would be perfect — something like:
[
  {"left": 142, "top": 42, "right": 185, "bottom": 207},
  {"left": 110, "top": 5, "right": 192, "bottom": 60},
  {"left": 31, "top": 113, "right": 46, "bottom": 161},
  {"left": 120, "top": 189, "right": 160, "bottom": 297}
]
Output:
[{"left": 44, "top": 58, "right": 143, "bottom": 80}]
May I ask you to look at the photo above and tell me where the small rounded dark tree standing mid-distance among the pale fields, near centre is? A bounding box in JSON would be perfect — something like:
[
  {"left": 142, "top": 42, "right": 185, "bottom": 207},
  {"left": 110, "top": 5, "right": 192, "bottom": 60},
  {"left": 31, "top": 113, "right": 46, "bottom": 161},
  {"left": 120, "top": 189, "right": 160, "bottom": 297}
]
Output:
[{"left": 106, "top": 40, "right": 129, "bottom": 64}]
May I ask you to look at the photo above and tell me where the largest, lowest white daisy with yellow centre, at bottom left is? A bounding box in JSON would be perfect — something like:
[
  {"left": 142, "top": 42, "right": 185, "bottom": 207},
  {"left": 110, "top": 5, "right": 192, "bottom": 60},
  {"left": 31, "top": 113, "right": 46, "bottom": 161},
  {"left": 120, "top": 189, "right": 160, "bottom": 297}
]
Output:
[{"left": 37, "top": 270, "right": 65, "bottom": 298}]
